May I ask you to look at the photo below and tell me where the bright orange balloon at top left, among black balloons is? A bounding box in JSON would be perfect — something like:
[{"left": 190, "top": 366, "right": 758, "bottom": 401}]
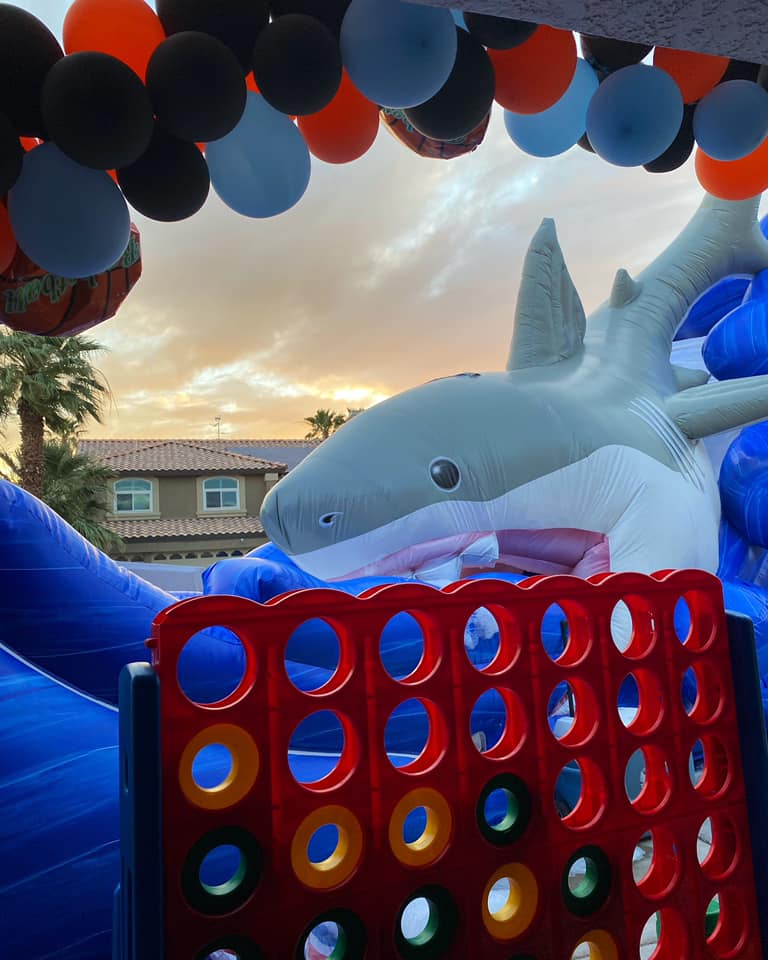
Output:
[{"left": 64, "top": 0, "right": 165, "bottom": 80}]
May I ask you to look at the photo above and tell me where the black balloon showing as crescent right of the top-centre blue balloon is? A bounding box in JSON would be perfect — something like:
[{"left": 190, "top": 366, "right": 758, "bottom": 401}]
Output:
[{"left": 405, "top": 28, "right": 496, "bottom": 140}]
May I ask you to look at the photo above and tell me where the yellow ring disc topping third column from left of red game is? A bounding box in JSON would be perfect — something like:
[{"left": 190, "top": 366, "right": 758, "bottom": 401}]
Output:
[{"left": 389, "top": 787, "right": 453, "bottom": 867}]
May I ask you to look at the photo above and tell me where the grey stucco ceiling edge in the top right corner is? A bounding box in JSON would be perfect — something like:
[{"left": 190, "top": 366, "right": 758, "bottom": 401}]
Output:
[{"left": 416, "top": 0, "right": 768, "bottom": 63}]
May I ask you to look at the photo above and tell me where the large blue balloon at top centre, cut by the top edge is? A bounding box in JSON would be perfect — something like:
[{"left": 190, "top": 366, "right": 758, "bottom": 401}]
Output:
[{"left": 341, "top": 0, "right": 457, "bottom": 109}]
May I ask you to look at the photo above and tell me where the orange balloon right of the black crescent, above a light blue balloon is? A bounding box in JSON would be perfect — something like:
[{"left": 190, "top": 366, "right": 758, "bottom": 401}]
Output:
[{"left": 488, "top": 26, "right": 576, "bottom": 113}]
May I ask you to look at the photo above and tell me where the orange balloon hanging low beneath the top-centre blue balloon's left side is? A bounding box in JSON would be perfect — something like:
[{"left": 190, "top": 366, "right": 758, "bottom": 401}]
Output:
[{"left": 299, "top": 70, "right": 379, "bottom": 163}]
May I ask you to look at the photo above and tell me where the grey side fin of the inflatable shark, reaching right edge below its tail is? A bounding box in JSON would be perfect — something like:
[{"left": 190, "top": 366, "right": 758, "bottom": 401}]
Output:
[{"left": 664, "top": 376, "right": 768, "bottom": 440}]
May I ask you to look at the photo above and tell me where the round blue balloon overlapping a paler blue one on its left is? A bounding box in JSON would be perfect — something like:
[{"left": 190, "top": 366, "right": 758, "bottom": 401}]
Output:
[{"left": 587, "top": 63, "right": 683, "bottom": 167}]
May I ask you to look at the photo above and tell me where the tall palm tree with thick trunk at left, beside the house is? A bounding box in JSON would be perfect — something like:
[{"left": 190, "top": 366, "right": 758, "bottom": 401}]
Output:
[{"left": 0, "top": 332, "right": 109, "bottom": 497}]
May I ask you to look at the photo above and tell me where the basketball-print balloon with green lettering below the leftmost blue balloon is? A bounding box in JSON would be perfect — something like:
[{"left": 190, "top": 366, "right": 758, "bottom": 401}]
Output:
[{"left": 0, "top": 224, "right": 141, "bottom": 337}]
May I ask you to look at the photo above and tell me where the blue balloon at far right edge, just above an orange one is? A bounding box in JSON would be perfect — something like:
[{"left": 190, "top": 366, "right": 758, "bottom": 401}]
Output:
[{"left": 693, "top": 80, "right": 768, "bottom": 160}]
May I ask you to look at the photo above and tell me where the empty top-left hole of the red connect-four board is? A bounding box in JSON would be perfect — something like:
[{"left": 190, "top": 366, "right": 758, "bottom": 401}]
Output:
[{"left": 176, "top": 626, "right": 249, "bottom": 708}]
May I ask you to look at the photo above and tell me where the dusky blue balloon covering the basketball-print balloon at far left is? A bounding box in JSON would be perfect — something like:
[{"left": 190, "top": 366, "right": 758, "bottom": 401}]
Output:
[{"left": 8, "top": 143, "right": 131, "bottom": 279}]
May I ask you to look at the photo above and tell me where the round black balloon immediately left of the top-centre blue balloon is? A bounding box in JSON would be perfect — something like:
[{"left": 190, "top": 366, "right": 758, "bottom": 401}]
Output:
[{"left": 253, "top": 13, "right": 341, "bottom": 116}]
